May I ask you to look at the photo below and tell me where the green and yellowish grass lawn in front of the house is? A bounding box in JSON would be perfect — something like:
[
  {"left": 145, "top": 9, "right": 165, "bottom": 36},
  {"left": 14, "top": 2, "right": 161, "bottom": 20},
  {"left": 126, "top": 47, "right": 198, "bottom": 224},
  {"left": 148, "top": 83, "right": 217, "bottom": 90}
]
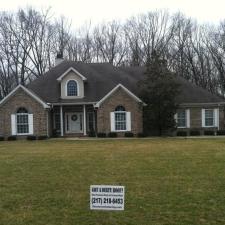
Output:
[{"left": 0, "top": 139, "right": 225, "bottom": 225}]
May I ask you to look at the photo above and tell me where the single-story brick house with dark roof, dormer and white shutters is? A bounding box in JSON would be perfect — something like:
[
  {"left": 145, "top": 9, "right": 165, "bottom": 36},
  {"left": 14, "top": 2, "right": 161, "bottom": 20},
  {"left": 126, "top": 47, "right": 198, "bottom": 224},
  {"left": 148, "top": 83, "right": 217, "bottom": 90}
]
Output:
[{"left": 0, "top": 61, "right": 225, "bottom": 137}]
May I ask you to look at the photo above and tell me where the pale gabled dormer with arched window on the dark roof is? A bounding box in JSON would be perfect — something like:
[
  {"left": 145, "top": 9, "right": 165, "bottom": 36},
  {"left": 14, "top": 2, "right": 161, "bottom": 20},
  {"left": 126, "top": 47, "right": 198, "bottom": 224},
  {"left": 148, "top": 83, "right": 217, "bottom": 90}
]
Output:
[{"left": 57, "top": 67, "right": 87, "bottom": 99}]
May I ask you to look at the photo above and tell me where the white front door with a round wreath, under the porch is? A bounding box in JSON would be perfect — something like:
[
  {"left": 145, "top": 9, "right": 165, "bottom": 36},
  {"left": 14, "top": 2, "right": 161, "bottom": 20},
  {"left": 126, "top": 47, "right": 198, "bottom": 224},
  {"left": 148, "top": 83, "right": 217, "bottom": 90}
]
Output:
[{"left": 65, "top": 113, "right": 83, "bottom": 133}]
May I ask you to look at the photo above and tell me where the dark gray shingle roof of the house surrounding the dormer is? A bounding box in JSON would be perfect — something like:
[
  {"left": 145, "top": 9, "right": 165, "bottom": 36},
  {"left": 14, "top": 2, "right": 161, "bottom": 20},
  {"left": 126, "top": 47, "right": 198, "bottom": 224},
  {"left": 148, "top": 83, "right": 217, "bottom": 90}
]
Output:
[{"left": 27, "top": 61, "right": 223, "bottom": 103}]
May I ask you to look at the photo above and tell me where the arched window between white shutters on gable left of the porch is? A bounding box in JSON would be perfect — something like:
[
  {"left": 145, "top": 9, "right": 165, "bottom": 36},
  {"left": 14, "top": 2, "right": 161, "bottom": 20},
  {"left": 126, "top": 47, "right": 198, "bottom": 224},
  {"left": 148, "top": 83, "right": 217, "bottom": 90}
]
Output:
[{"left": 16, "top": 108, "right": 29, "bottom": 134}]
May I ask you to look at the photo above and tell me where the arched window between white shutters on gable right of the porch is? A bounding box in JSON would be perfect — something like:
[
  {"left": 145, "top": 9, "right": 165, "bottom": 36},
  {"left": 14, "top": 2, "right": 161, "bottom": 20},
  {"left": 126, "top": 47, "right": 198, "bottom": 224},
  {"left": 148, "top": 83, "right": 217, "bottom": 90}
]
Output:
[{"left": 115, "top": 106, "right": 127, "bottom": 131}]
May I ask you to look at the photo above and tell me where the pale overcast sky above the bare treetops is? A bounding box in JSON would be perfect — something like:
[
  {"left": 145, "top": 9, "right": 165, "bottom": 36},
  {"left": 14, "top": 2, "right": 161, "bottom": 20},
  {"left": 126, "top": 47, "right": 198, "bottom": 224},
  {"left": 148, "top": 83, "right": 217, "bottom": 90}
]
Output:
[{"left": 0, "top": 0, "right": 225, "bottom": 28}]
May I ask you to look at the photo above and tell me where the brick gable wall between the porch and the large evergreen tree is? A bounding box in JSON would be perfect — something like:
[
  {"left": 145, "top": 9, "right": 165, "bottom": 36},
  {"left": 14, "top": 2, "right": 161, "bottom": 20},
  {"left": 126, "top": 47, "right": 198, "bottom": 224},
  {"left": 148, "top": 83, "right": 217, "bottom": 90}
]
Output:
[{"left": 97, "top": 88, "right": 143, "bottom": 135}]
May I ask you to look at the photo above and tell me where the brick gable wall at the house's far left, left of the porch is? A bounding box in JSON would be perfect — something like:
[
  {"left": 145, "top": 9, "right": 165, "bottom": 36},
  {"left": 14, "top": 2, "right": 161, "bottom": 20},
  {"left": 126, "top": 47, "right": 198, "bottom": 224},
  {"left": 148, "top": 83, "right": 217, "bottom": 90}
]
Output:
[{"left": 0, "top": 89, "right": 50, "bottom": 137}]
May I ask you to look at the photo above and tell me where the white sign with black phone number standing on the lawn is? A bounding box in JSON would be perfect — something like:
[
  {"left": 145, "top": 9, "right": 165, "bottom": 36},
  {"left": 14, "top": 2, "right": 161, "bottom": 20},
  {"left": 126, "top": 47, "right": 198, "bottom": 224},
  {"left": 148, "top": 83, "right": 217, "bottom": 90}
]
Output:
[{"left": 90, "top": 185, "right": 125, "bottom": 210}]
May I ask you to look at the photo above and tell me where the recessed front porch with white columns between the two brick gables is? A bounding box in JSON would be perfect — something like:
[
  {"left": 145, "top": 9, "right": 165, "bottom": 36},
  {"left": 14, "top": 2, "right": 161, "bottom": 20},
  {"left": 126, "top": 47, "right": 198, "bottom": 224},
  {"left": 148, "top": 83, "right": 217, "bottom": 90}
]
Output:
[{"left": 52, "top": 104, "right": 97, "bottom": 137}]
